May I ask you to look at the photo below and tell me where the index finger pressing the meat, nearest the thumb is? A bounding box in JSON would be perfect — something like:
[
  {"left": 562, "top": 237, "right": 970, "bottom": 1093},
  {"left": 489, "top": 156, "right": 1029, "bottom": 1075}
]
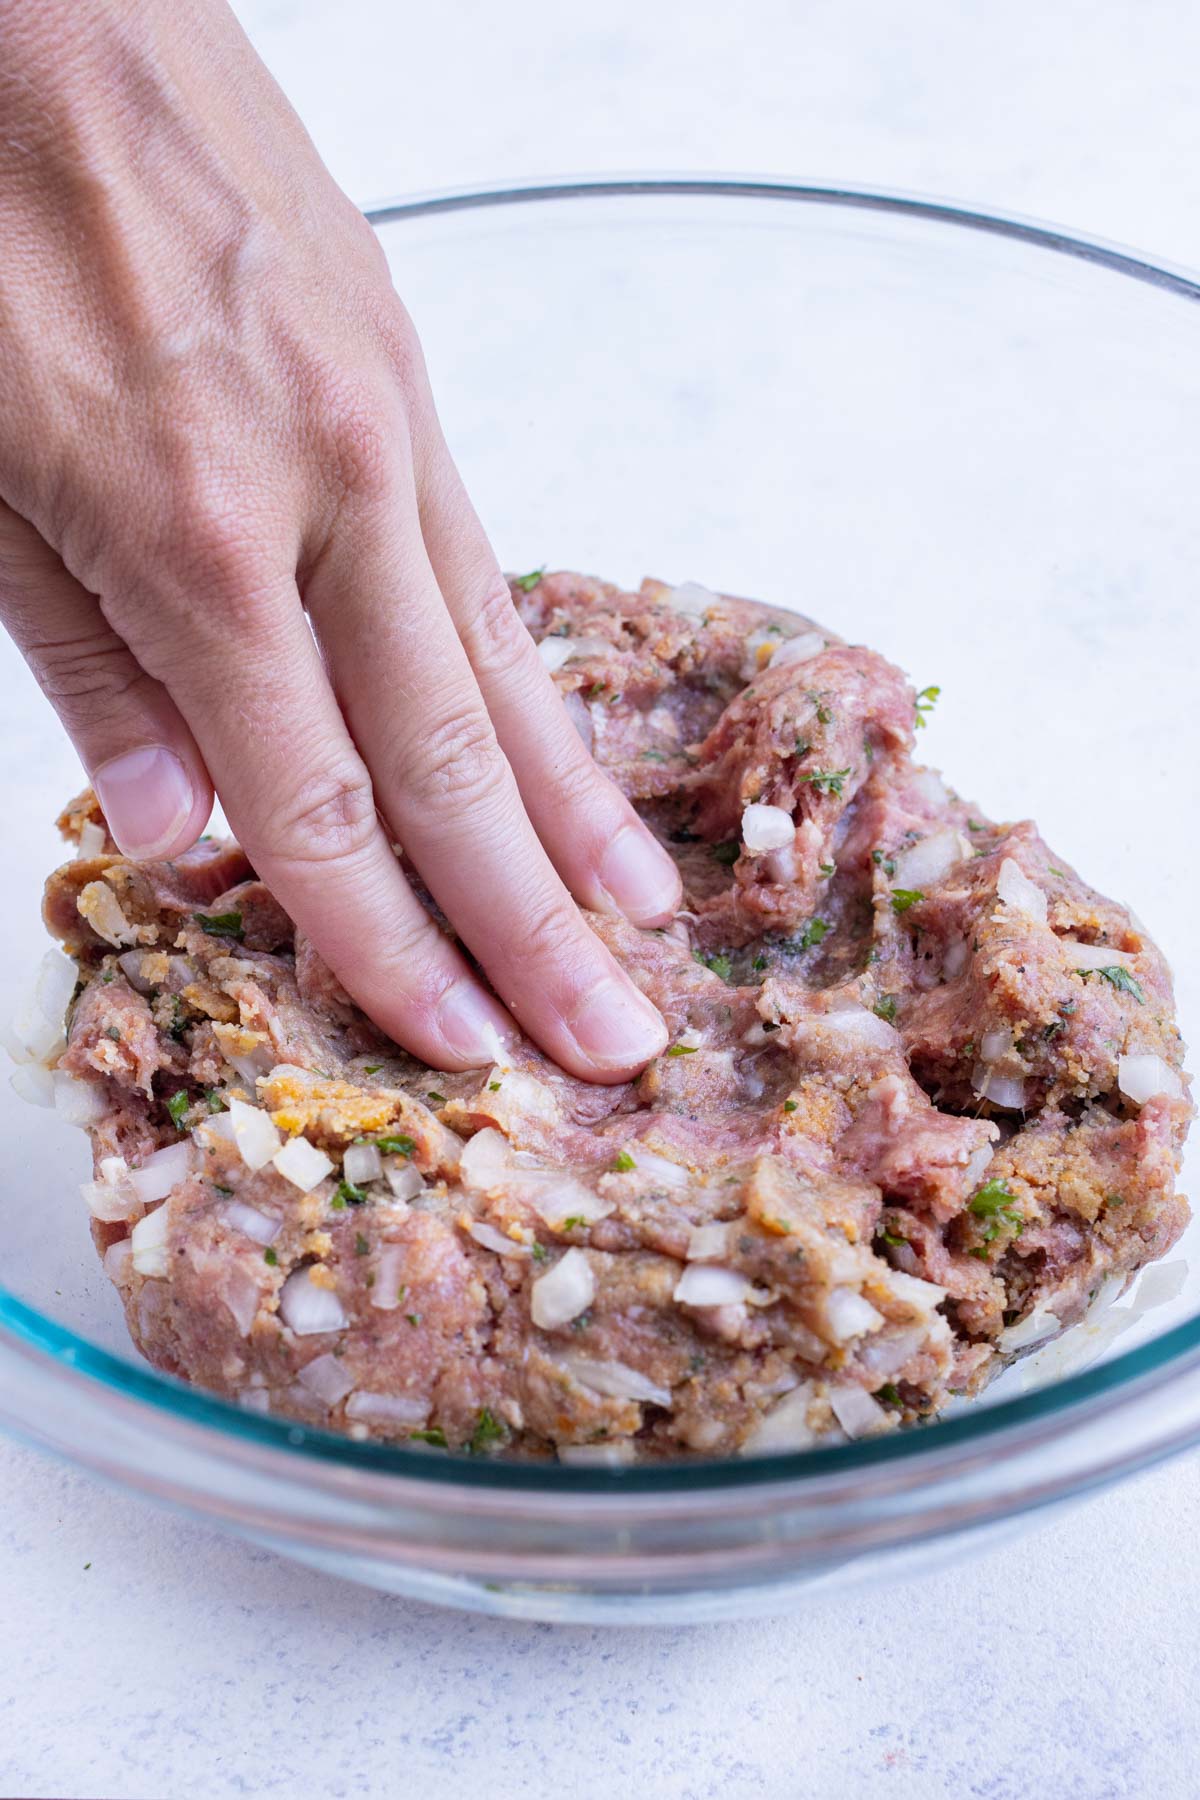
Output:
[{"left": 134, "top": 587, "right": 513, "bottom": 1069}]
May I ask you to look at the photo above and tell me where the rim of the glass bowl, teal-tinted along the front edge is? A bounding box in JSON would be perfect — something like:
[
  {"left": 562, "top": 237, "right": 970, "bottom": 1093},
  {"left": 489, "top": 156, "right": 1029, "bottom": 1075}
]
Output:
[{"left": 0, "top": 173, "right": 1200, "bottom": 1499}]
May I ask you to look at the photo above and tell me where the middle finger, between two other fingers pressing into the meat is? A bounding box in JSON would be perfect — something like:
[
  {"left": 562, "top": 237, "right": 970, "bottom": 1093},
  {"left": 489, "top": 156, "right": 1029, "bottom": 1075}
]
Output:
[{"left": 306, "top": 495, "right": 666, "bottom": 1082}]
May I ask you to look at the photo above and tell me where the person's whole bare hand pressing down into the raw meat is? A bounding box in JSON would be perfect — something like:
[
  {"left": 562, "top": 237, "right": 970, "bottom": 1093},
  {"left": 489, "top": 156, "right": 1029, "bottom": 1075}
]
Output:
[{"left": 0, "top": 0, "right": 678, "bottom": 1082}]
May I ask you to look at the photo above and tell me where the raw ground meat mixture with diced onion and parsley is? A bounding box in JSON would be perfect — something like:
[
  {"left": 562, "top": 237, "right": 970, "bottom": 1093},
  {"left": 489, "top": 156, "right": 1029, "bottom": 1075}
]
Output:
[{"left": 27, "top": 574, "right": 1191, "bottom": 1462}]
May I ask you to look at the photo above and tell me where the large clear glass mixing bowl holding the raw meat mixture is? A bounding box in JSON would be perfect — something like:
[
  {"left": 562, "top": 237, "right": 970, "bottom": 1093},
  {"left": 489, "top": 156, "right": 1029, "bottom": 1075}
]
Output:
[{"left": 0, "top": 180, "right": 1200, "bottom": 1620}]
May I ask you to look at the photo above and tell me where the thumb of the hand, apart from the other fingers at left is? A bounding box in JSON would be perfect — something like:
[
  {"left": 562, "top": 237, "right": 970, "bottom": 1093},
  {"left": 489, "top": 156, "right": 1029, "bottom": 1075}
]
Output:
[{"left": 0, "top": 504, "right": 212, "bottom": 860}]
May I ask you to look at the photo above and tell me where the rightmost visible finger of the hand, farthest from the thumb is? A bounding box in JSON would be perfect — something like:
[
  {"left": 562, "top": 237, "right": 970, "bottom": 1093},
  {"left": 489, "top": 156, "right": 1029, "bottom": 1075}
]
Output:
[{"left": 413, "top": 425, "right": 682, "bottom": 925}]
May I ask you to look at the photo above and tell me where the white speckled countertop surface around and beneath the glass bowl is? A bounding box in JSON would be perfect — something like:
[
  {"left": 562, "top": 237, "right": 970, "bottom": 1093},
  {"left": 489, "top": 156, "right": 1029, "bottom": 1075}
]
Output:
[{"left": 0, "top": 0, "right": 1200, "bottom": 1800}]
